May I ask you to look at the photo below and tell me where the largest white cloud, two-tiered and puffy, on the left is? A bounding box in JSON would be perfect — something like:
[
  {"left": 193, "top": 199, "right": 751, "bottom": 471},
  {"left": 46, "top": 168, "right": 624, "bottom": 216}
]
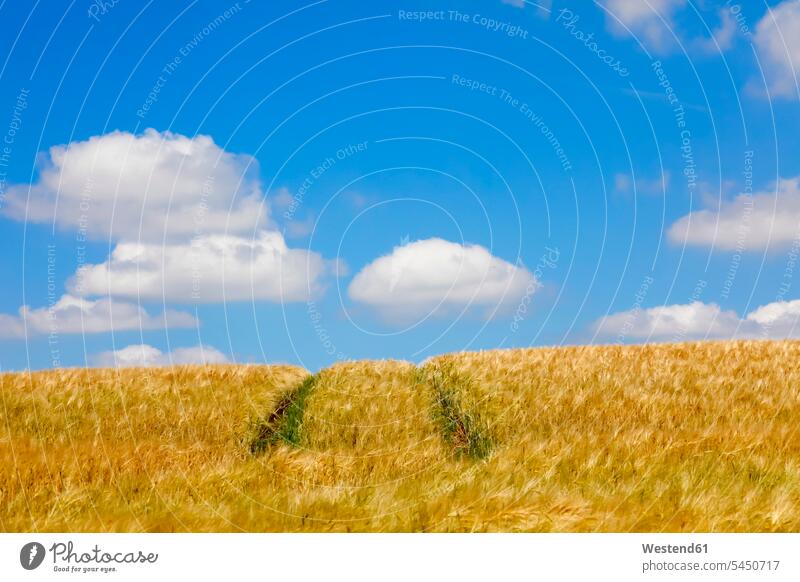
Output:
[{"left": 4, "top": 129, "right": 339, "bottom": 303}]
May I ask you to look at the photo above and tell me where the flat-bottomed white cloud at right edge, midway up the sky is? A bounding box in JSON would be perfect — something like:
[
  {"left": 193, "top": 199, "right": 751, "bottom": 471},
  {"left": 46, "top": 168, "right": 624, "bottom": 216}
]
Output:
[{"left": 668, "top": 177, "right": 800, "bottom": 251}]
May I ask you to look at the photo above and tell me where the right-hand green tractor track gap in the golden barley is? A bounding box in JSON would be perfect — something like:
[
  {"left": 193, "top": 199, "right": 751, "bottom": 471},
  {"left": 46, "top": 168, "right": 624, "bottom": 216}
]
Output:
[{"left": 420, "top": 364, "right": 492, "bottom": 459}]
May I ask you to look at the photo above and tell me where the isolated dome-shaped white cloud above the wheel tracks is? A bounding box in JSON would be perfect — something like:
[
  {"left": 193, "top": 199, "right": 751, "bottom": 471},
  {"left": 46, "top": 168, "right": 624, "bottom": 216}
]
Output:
[{"left": 348, "top": 238, "right": 538, "bottom": 319}]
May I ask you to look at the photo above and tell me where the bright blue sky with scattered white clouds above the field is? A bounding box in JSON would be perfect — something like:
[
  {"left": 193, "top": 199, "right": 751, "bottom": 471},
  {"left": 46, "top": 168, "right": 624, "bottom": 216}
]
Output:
[{"left": 0, "top": 0, "right": 800, "bottom": 369}]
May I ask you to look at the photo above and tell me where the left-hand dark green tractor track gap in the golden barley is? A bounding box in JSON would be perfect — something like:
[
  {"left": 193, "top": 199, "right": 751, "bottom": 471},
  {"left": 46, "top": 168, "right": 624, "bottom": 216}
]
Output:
[{"left": 250, "top": 376, "right": 316, "bottom": 455}]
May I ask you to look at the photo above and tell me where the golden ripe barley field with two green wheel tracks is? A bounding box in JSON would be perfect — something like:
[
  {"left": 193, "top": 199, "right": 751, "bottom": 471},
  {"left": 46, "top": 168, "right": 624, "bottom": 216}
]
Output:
[{"left": 0, "top": 341, "right": 800, "bottom": 532}]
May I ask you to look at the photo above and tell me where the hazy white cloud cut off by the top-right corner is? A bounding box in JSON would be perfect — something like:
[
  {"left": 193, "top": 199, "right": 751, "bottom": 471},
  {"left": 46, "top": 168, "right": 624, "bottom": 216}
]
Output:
[{"left": 751, "top": 0, "right": 800, "bottom": 98}]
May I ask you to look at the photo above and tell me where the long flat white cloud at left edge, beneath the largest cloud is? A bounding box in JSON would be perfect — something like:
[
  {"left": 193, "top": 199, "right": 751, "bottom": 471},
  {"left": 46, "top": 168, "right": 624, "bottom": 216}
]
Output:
[{"left": 0, "top": 295, "right": 197, "bottom": 338}]
